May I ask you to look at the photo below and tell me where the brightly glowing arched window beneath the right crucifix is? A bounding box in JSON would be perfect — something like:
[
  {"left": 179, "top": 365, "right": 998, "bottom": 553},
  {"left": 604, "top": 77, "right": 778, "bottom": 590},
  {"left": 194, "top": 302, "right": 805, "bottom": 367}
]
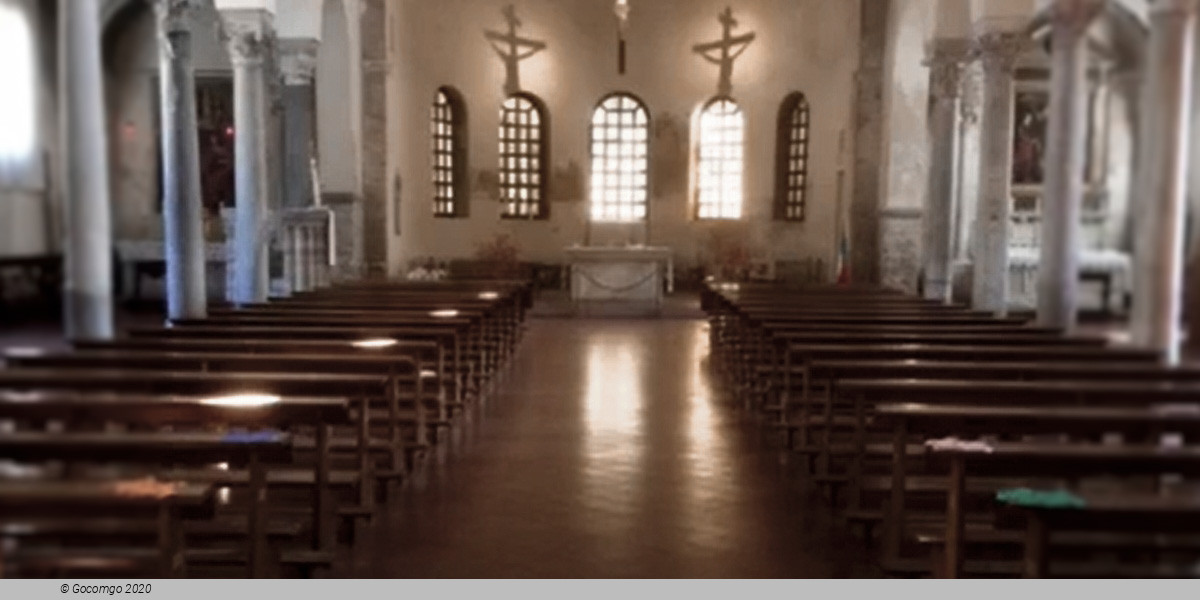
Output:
[{"left": 696, "top": 97, "right": 745, "bottom": 218}]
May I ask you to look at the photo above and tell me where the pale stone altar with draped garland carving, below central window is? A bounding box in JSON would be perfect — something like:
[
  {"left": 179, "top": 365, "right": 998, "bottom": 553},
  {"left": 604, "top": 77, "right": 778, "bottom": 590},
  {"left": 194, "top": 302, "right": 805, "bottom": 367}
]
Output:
[{"left": 565, "top": 246, "right": 674, "bottom": 313}]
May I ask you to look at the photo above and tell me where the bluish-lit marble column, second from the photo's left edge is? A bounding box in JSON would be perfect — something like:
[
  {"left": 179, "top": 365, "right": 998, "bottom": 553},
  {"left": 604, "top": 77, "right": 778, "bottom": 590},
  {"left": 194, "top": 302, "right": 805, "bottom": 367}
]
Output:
[{"left": 155, "top": 0, "right": 208, "bottom": 319}]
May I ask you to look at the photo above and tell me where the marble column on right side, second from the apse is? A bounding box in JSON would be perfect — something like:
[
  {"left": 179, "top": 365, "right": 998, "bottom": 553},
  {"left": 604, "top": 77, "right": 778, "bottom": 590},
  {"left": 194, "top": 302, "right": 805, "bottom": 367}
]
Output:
[{"left": 972, "top": 31, "right": 1027, "bottom": 314}]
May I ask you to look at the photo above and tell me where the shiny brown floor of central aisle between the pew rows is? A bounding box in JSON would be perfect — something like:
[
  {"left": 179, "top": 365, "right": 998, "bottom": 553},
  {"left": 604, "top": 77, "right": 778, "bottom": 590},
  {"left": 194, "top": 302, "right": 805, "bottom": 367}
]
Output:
[{"left": 346, "top": 319, "right": 875, "bottom": 577}]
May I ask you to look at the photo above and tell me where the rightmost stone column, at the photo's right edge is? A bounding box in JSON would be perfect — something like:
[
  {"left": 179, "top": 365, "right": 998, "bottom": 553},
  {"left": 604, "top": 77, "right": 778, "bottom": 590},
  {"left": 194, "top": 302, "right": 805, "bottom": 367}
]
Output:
[{"left": 1132, "top": 0, "right": 1198, "bottom": 364}]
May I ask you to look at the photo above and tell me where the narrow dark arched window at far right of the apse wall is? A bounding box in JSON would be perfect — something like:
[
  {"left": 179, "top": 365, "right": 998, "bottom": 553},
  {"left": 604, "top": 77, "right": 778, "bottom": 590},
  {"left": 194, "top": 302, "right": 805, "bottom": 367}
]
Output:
[{"left": 775, "top": 92, "right": 809, "bottom": 221}]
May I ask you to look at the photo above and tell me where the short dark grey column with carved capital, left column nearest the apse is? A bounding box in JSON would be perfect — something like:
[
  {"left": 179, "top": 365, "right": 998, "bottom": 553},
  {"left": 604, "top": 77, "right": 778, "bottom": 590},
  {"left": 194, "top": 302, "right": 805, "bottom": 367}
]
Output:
[{"left": 280, "top": 40, "right": 318, "bottom": 208}]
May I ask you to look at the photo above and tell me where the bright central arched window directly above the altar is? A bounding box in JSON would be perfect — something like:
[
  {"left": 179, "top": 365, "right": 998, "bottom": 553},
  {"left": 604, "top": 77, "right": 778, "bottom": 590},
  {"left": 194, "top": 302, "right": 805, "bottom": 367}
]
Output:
[{"left": 592, "top": 94, "right": 650, "bottom": 222}]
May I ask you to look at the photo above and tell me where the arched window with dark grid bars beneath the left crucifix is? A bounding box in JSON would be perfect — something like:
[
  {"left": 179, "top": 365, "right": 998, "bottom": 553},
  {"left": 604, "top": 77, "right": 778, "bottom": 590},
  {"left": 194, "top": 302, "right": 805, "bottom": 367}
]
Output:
[{"left": 499, "top": 94, "right": 548, "bottom": 218}]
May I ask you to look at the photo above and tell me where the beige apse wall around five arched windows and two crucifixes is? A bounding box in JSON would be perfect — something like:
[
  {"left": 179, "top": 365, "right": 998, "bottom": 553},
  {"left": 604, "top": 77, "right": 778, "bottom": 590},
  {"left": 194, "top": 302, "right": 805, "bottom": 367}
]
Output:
[{"left": 388, "top": 0, "right": 859, "bottom": 272}]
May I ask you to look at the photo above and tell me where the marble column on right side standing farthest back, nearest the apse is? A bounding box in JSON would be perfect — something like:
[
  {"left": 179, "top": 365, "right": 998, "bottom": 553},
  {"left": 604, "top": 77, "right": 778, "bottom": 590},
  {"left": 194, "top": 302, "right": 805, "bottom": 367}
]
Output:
[{"left": 923, "top": 40, "right": 966, "bottom": 302}]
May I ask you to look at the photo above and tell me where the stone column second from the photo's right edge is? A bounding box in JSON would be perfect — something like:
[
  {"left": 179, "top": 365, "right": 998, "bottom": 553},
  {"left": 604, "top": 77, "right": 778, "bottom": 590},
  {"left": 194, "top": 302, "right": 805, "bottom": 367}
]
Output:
[{"left": 1038, "top": 0, "right": 1103, "bottom": 331}]
